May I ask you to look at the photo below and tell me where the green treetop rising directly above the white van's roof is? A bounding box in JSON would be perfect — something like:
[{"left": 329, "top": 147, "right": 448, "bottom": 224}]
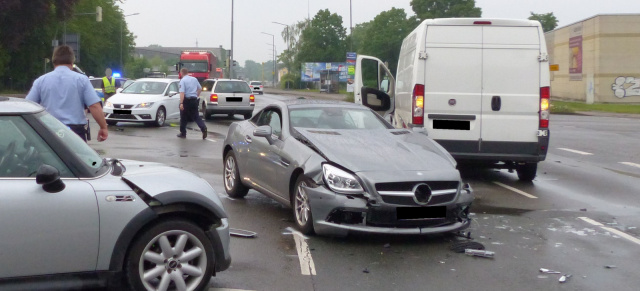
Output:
[{"left": 411, "top": 0, "right": 482, "bottom": 20}]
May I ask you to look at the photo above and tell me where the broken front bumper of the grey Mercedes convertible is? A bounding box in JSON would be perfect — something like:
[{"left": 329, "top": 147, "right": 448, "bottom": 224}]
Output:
[{"left": 306, "top": 186, "right": 473, "bottom": 236}]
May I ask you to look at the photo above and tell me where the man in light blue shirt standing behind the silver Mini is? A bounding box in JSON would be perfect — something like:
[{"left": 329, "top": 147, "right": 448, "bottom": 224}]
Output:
[{"left": 26, "top": 45, "right": 109, "bottom": 141}]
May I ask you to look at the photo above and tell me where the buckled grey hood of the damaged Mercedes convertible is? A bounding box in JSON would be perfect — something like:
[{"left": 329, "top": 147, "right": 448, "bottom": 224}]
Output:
[{"left": 297, "top": 128, "right": 455, "bottom": 172}]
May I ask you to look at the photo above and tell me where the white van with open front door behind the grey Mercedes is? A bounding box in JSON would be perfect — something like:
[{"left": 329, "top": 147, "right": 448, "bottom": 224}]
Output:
[{"left": 355, "top": 18, "right": 550, "bottom": 181}]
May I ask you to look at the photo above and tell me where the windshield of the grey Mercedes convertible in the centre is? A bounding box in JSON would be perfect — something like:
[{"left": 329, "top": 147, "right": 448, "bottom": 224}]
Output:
[{"left": 289, "top": 107, "right": 389, "bottom": 129}]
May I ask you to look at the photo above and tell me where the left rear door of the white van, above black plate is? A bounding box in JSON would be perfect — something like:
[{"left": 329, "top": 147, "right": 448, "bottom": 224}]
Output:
[{"left": 424, "top": 25, "right": 483, "bottom": 156}]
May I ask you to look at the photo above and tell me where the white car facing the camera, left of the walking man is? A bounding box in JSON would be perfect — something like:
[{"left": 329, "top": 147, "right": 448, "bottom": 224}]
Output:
[{"left": 104, "top": 78, "right": 180, "bottom": 126}]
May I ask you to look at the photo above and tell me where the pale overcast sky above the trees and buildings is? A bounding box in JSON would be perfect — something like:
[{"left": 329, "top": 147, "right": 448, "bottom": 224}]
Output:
[{"left": 120, "top": 0, "right": 640, "bottom": 66}]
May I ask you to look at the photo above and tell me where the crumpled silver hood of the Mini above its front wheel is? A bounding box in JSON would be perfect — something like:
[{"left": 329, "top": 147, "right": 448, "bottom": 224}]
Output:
[{"left": 120, "top": 160, "right": 227, "bottom": 218}]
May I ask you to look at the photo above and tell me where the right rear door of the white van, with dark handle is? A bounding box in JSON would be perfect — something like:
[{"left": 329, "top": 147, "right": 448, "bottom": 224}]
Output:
[{"left": 480, "top": 25, "right": 541, "bottom": 154}]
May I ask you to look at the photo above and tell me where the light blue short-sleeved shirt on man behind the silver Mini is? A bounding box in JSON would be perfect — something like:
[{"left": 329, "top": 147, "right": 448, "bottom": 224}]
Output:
[{"left": 25, "top": 66, "right": 100, "bottom": 125}]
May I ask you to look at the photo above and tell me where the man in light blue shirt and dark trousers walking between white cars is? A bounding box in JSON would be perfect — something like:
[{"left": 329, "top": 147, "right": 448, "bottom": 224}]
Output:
[{"left": 178, "top": 68, "right": 207, "bottom": 139}]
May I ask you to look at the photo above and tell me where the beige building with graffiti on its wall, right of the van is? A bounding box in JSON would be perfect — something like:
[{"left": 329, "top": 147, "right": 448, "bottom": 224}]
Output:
[{"left": 545, "top": 14, "right": 640, "bottom": 103}]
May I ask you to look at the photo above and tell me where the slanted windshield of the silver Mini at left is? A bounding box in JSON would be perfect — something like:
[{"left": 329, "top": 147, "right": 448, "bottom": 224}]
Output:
[{"left": 38, "top": 114, "right": 104, "bottom": 174}]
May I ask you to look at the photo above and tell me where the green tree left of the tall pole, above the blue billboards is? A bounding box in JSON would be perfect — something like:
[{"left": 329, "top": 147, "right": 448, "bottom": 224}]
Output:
[{"left": 293, "top": 9, "right": 347, "bottom": 68}]
